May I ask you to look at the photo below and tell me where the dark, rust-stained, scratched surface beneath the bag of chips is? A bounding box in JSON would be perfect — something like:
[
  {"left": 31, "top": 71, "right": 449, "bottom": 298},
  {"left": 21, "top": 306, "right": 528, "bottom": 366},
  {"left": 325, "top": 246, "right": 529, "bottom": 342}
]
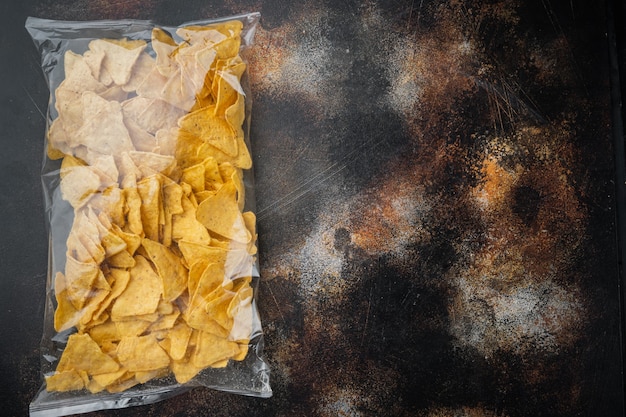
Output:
[{"left": 0, "top": 0, "right": 623, "bottom": 417}]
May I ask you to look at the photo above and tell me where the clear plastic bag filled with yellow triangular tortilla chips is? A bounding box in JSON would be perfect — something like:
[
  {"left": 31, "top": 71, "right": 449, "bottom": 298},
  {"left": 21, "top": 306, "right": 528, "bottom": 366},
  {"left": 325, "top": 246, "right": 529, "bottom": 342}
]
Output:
[{"left": 26, "top": 13, "right": 272, "bottom": 416}]
